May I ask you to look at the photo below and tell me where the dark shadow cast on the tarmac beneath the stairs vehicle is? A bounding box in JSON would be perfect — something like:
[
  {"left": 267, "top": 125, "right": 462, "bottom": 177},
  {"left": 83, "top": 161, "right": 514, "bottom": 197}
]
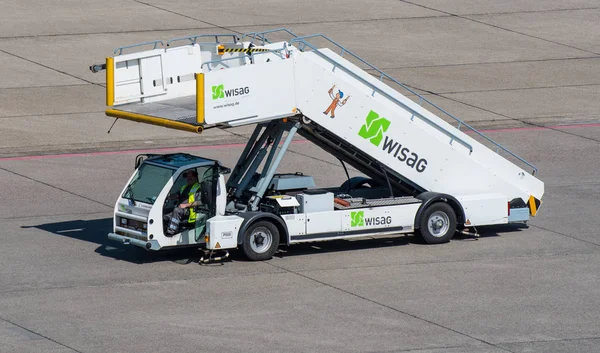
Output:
[{"left": 22, "top": 218, "right": 528, "bottom": 265}]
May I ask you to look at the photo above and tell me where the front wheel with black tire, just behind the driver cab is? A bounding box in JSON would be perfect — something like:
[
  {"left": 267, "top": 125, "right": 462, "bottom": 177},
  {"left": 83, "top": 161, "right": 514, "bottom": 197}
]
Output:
[{"left": 242, "top": 221, "right": 279, "bottom": 261}]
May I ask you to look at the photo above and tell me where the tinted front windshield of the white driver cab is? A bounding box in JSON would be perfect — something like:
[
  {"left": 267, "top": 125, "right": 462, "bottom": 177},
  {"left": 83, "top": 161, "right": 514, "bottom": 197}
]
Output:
[{"left": 121, "top": 164, "right": 175, "bottom": 204}]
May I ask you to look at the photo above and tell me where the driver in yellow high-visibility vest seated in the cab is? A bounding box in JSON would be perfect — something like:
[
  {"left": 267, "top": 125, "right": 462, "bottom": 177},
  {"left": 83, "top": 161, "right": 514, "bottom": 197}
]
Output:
[{"left": 165, "top": 169, "right": 200, "bottom": 237}]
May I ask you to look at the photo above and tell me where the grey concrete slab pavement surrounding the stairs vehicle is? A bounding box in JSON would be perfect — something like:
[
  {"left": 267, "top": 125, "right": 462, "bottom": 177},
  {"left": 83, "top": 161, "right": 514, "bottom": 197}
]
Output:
[{"left": 0, "top": 0, "right": 600, "bottom": 353}]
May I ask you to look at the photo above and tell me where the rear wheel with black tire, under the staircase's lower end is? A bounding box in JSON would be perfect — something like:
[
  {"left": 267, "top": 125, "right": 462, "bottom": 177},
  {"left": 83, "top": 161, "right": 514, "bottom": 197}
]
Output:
[{"left": 419, "top": 202, "right": 456, "bottom": 244}]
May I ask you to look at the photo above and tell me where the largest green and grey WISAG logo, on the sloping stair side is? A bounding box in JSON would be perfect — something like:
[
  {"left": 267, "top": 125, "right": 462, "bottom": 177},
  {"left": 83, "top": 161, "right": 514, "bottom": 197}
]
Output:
[{"left": 358, "top": 110, "right": 427, "bottom": 173}]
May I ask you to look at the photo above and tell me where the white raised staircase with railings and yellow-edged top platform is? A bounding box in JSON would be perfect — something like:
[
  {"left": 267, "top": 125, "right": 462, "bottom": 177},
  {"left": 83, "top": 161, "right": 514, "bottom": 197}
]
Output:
[{"left": 102, "top": 30, "right": 544, "bottom": 208}]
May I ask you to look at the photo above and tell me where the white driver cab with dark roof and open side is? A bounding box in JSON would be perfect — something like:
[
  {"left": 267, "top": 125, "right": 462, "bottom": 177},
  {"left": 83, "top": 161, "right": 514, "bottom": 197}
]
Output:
[{"left": 109, "top": 153, "right": 230, "bottom": 250}]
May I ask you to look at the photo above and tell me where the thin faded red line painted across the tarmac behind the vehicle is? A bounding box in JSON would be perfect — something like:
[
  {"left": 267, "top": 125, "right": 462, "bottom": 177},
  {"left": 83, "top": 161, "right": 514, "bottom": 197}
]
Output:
[{"left": 0, "top": 123, "right": 600, "bottom": 161}]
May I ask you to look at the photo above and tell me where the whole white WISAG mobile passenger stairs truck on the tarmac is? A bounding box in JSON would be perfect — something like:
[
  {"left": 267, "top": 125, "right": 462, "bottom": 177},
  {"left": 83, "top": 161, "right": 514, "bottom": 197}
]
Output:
[{"left": 90, "top": 29, "right": 544, "bottom": 261}]
